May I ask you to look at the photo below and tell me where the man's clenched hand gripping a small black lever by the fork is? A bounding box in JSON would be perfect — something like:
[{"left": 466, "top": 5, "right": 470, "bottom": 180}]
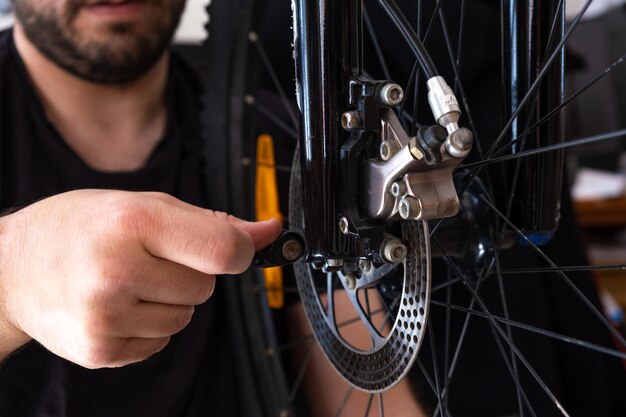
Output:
[{"left": 0, "top": 190, "right": 280, "bottom": 368}]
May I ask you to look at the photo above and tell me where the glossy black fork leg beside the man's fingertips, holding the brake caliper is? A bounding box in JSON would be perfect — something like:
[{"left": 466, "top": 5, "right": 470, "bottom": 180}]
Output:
[{"left": 292, "top": 0, "right": 362, "bottom": 266}]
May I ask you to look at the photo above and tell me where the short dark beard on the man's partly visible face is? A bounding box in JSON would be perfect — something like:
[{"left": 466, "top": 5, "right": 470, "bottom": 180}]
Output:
[{"left": 14, "top": 0, "right": 185, "bottom": 84}]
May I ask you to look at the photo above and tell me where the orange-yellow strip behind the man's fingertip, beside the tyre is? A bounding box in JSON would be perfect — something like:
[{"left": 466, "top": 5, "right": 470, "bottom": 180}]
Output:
[{"left": 254, "top": 135, "right": 285, "bottom": 308}]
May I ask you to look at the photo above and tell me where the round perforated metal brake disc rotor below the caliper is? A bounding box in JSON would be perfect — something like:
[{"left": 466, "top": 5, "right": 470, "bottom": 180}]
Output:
[{"left": 289, "top": 152, "right": 430, "bottom": 393}]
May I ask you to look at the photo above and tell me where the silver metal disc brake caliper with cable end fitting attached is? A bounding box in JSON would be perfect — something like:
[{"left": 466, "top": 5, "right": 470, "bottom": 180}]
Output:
[{"left": 362, "top": 77, "right": 473, "bottom": 220}]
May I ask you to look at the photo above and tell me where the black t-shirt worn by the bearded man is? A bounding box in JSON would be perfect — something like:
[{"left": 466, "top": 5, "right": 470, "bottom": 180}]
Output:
[{"left": 0, "top": 31, "right": 237, "bottom": 417}]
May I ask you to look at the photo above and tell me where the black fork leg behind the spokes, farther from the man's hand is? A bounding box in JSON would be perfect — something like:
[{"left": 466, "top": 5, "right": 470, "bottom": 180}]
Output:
[{"left": 500, "top": 0, "right": 565, "bottom": 243}]
